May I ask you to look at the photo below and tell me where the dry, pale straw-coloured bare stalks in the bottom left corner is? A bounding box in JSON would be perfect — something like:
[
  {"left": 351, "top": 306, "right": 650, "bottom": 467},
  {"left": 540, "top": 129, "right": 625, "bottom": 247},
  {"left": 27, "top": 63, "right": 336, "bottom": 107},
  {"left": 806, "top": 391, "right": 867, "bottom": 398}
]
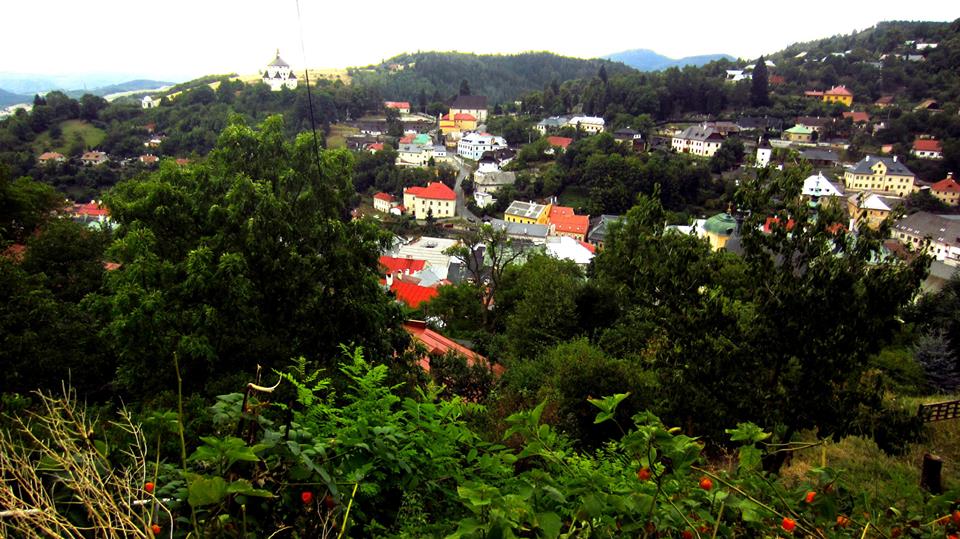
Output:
[{"left": 0, "top": 389, "right": 166, "bottom": 538}]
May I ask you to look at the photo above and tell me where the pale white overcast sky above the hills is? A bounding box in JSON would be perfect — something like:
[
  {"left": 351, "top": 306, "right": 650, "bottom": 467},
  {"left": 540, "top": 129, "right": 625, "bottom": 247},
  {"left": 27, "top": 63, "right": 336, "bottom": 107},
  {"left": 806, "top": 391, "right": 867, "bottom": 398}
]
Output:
[{"left": 0, "top": 0, "right": 960, "bottom": 80}]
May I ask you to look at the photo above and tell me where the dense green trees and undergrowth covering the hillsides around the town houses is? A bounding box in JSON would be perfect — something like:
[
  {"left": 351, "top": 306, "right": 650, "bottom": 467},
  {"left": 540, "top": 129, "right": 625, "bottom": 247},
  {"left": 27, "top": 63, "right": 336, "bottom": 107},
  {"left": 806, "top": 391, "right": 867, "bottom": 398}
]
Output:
[{"left": 0, "top": 17, "right": 960, "bottom": 539}]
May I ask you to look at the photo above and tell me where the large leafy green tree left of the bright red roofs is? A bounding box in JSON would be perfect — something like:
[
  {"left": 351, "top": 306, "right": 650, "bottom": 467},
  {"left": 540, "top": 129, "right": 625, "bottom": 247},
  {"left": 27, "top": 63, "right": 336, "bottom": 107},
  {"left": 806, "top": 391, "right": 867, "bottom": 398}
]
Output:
[{"left": 100, "top": 117, "right": 406, "bottom": 391}]
